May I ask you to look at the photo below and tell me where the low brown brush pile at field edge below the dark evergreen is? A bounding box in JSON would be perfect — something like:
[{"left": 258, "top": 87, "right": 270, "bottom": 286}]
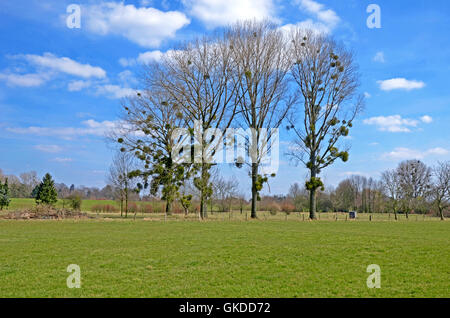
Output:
[{"left": 1, "top": 206, "right": 89, "bottom": 220}]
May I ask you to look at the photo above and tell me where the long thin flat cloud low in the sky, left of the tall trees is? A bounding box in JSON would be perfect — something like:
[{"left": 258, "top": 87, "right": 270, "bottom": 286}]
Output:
[{"left": 6, "top": 119, "right": 120, "bottom": 139}]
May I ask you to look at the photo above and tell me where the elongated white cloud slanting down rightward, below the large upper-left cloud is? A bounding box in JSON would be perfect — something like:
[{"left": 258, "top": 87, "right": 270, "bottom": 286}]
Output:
[{"left": 22, "top": 53, "right": 106, "bottom": 78}]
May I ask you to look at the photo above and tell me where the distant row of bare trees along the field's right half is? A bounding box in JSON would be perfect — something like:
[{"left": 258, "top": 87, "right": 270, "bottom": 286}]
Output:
[{"left": 261, "top": 160, "right": 450, "bottom": 219}]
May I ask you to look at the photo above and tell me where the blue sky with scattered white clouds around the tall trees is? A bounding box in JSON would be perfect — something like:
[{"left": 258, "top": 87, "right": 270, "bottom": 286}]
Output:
[{"left": 0, "top": 0, "right": 450, "bottom": 194}]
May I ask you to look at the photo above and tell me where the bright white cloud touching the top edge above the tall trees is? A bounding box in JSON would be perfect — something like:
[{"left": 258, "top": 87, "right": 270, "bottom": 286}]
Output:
[{"left": 183, "top": 0, "right": 276, "bottom": 28}]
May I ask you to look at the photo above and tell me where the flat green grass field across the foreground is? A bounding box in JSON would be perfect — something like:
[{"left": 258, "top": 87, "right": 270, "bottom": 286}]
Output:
[{"left": 0, "top": 217, "right": 450, "bottom": 297}]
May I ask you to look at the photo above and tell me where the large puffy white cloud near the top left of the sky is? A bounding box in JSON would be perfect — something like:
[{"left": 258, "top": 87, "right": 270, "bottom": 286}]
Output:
[{"left": 83, "top": 2, "right": 190, "bottom": 47}]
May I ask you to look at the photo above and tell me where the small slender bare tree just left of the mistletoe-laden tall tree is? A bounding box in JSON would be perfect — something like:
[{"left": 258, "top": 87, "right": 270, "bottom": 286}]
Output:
[{"left": 108, "top": 152, "right": 135, "bottom": 217}]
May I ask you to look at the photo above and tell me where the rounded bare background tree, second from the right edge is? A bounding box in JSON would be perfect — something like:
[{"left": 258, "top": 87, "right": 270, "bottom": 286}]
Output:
[{"left": 396, "top": 160, "right": 432, "bottom": 218}]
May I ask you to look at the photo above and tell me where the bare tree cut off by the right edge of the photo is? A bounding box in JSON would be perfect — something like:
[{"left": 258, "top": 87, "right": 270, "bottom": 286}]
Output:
[{"left": 432, "top": 161, "right": 450, "bottom": 221}]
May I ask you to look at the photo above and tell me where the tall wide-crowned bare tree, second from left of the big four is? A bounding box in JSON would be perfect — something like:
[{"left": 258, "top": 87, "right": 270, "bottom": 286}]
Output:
[{"left": 160, "top": 35, "right": 243, "bottom": 218}]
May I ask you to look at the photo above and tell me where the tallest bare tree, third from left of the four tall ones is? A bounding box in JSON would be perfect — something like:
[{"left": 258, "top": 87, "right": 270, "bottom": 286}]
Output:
[{"left": 227, "top": 21, "right": 291, "bottom": 218}]
